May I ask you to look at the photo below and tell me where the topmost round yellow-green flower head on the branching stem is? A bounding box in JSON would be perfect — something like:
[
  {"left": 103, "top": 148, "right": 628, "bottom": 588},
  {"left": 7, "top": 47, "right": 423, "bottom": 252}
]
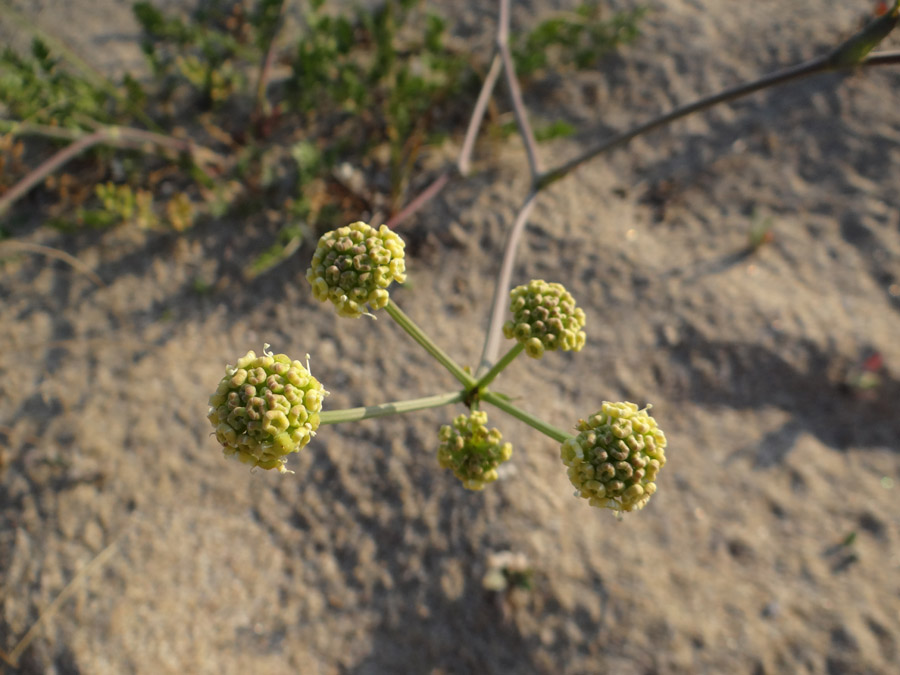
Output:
[{"left": 306, "top": 222, "right": 406, "bottom": 318}]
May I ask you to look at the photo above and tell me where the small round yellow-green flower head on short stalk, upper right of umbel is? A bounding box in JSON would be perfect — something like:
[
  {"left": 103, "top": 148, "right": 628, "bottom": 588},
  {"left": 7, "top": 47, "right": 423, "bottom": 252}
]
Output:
[{"left": 503, "top": 279, "right": 585, "bottom": 359}]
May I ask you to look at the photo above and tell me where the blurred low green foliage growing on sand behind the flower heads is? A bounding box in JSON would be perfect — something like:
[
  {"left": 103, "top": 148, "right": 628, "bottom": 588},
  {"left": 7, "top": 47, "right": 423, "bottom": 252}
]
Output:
[{"left": 0, "top": 0, "right": 648, "bottom": 262}]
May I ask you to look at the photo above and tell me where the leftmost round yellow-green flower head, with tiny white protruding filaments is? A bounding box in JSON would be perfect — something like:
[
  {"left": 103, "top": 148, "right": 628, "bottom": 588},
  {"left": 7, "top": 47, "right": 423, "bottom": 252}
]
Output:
[{"left": 208, "top": 345, "right": 328, "bottom": 473}]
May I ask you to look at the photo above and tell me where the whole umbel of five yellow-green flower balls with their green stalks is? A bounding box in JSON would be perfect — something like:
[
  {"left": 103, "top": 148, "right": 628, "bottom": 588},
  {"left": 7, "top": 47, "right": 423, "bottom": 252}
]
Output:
[{"left": 209, "top": 222, "right": 666, "bottom": 512}]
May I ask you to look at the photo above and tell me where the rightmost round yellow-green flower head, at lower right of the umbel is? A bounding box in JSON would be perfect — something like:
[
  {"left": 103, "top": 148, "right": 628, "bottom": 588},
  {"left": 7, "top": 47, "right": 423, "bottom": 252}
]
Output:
[{"left": 560, "top": 401, "right": 666, "bottom": 511}]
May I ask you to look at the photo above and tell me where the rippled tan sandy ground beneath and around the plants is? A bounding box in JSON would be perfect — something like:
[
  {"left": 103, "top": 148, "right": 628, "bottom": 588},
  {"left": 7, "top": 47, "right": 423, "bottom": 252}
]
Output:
[{"left": 0, "top": 0, "right": 900, "bottom": 675}]
